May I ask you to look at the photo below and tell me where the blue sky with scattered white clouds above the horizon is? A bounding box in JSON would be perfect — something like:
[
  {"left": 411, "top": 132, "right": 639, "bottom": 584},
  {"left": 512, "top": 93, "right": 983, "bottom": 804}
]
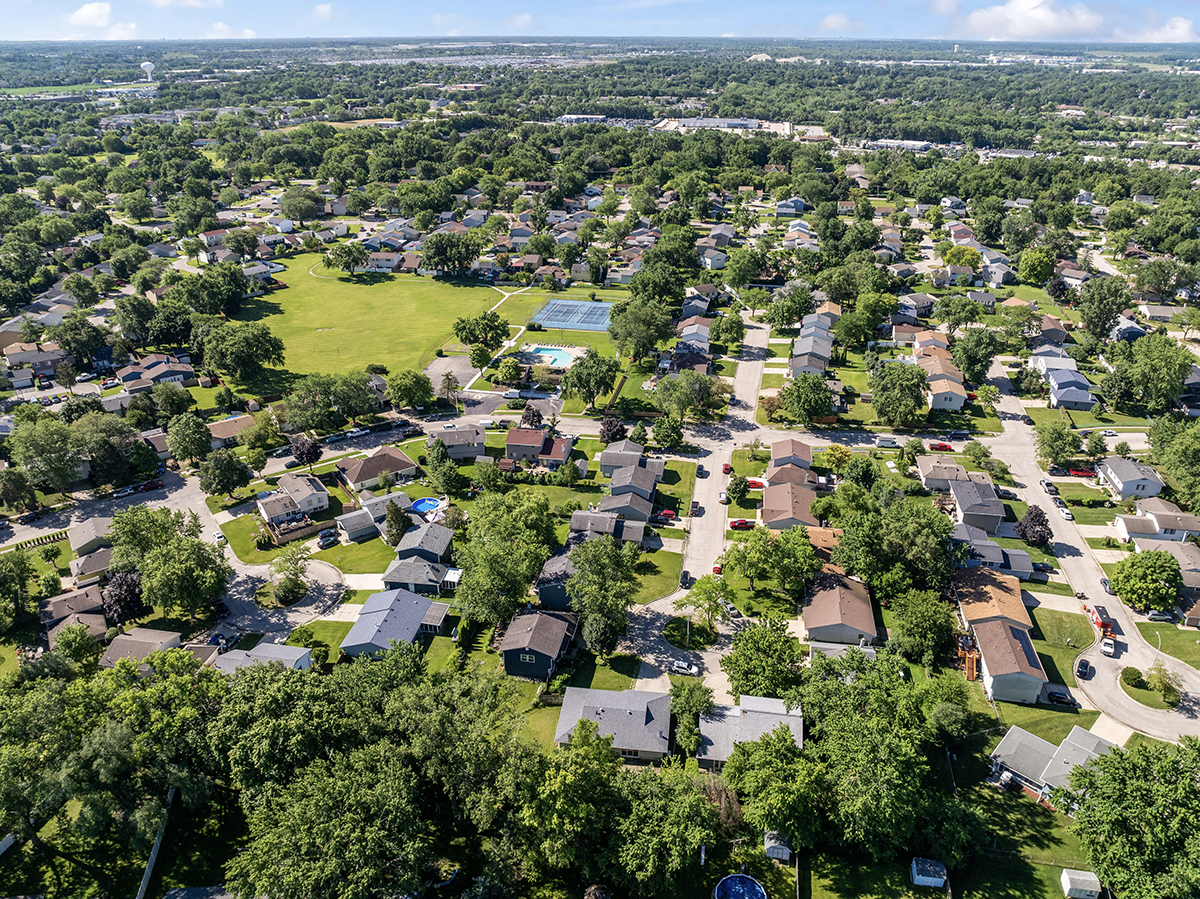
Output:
[{"left": 7, "top": 0, "right": 1200, "bottom": 43}]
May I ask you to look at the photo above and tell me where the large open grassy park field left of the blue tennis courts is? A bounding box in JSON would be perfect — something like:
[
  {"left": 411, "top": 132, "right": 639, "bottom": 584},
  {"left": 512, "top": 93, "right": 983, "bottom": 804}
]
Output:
[{"left": 236, "top": 262, "right": 497, "bottom": 394}]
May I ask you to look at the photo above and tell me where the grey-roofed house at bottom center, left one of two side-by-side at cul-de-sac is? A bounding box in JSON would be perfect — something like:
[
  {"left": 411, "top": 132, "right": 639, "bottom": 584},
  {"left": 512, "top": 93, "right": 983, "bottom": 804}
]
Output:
[{"left": 554, "top": 687, "right": 671, "bottom": 761}]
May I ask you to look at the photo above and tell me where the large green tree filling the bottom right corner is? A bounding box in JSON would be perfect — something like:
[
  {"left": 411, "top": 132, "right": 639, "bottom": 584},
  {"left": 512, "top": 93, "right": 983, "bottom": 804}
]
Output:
[{"left": 1051, "top": 737, "right": 1200, "bottom": 899}]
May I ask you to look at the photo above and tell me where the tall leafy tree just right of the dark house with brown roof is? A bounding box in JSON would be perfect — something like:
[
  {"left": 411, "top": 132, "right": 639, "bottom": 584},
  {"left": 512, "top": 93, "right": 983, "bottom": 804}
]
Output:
[{"left": 566, "top": 534, "right": 641, "bottom": 657}]
